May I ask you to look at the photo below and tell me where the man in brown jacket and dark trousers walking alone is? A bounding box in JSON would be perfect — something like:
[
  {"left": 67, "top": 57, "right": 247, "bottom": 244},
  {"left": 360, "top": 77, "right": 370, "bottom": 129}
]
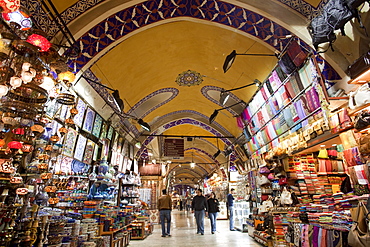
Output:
[{"left": 158, "top": 190, "right": 172, "bottom": 237}]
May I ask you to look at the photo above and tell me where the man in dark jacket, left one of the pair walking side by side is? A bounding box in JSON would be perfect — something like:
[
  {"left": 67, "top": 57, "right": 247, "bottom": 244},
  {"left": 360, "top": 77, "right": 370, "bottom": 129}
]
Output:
[{"left": 191, "top": 189, "right": 208, "bottom": 235}]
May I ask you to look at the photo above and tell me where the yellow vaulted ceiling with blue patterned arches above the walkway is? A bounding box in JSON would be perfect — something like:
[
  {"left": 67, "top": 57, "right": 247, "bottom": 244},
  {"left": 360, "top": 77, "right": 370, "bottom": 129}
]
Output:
[{"left": 22, "top": 0, "right": 369, "bottom": 185}]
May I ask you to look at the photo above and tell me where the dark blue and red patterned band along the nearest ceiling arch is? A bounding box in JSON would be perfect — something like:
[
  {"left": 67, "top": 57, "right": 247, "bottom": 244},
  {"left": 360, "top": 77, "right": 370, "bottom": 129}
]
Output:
[{"left": 22, "top": 0, "right": 340, "bottom": 80}]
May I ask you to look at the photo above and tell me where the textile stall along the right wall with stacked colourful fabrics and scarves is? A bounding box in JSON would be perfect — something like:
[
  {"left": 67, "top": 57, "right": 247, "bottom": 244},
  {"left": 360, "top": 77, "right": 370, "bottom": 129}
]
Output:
[{"left": 235, "top": 45, "right": 370, "bottom": 246}]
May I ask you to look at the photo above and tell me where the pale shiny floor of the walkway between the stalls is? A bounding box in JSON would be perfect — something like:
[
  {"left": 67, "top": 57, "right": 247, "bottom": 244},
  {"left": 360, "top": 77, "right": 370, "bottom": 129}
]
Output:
[{"left": 129, "top": 210, "right": 261, "bottom": 247}]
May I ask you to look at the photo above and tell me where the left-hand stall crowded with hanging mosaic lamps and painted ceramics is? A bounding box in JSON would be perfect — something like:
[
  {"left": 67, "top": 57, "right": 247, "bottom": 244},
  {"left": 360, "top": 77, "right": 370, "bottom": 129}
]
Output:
[{"left": 0, "top": 0, "right": 145, "bottom": 247}]
